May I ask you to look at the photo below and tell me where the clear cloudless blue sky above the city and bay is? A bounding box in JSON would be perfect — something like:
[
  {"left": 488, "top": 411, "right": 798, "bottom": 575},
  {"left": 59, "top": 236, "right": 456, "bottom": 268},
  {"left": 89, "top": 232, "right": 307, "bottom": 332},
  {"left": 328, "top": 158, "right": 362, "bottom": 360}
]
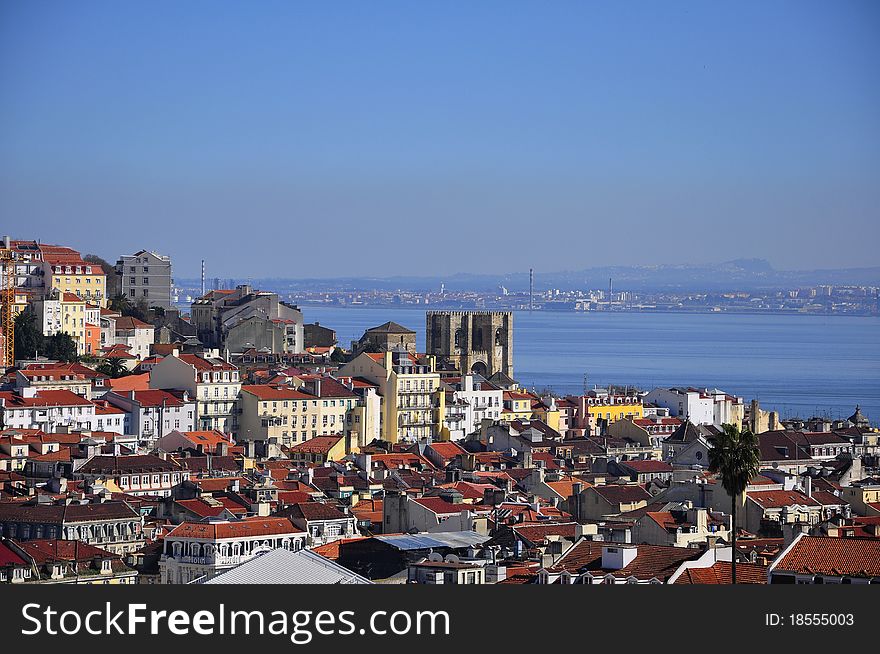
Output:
[{"left": 0, "top": 0, "right": 880, "bottom": 278}]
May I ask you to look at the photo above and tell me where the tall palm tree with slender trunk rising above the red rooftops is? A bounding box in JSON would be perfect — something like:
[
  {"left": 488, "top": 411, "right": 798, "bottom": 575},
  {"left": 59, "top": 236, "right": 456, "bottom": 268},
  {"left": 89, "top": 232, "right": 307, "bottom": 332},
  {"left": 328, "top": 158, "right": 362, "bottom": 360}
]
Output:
[{"left": 709, "top": 424, "right": 761, "bottom": 584}]
